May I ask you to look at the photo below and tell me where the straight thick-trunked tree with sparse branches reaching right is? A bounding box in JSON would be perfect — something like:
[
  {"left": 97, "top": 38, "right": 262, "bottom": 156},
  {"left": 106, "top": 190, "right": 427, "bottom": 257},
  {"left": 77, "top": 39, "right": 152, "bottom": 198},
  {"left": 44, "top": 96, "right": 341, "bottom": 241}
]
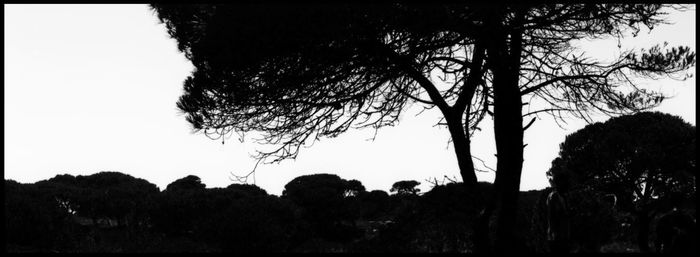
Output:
[{"left": 470, "top": 4, "right": 695, "bottom": 250}]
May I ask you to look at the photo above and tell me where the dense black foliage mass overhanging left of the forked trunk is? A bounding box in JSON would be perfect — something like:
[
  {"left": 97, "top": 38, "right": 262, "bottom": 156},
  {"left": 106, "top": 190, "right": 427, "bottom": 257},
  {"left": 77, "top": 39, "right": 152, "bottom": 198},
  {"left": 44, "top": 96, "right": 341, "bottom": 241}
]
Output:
[{"left": 152, "top": 4, "right": 458, "bottom": 161}]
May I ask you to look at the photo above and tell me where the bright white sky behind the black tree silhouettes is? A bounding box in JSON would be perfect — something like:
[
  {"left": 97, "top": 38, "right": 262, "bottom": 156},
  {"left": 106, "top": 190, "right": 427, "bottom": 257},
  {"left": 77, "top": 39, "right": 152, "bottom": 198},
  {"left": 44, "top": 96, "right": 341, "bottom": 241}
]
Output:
[{"left": 4, "top": 5, "right": 696, "bottom": 195}]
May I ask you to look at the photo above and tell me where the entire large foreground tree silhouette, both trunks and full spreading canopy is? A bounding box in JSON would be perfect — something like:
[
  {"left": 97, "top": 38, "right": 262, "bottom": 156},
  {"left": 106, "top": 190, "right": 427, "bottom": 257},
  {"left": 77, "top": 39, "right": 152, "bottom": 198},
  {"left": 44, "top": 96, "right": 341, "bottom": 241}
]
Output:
[{"left": 153, "top": 4, "right": 695, "bottom": 251}]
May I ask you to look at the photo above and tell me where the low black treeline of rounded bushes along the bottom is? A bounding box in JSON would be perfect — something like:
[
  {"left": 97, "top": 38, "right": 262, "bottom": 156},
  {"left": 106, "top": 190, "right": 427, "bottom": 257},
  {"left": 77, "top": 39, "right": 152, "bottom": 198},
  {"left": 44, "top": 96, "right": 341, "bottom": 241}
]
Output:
[{"left": 5, "top": 172, "right": 688, "bottom": 252}]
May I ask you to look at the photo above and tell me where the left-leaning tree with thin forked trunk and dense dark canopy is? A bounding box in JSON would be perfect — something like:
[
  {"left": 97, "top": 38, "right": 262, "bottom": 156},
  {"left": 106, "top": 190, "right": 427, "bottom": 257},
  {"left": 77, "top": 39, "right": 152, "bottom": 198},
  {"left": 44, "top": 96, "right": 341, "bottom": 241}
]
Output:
[{"left": 152, "top": 4, "right": 492, "bottom": 184}]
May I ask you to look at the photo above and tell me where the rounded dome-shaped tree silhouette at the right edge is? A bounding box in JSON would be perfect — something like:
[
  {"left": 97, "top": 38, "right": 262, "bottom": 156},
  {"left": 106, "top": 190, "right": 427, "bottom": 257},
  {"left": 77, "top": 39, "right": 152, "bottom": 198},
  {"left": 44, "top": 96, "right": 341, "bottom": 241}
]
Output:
[{"left": 548, "top": 112, "right": 696, "bottom": 251}]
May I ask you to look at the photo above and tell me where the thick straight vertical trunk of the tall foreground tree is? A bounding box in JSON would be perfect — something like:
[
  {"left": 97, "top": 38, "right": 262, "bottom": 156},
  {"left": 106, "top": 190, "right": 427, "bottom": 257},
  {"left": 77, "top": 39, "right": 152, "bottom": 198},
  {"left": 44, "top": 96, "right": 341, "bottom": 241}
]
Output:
[{"left": 489, "top": 7, "right": 523, "bottom": 253}]
